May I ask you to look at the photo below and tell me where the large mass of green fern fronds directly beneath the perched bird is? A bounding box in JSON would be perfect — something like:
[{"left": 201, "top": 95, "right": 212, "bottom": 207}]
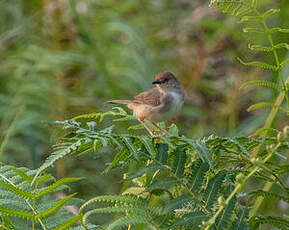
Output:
[{"left": 35, "top": 108, "right": 289, "bottom": 229}]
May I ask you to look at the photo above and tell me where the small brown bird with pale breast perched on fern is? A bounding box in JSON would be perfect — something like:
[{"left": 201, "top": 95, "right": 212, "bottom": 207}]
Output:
[{"left": 107, "top": 72, "right": 184, "bottom": 137}]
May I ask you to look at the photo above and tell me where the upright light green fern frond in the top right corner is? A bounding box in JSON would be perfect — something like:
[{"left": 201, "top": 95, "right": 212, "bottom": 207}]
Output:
[{"left": 210, "top": 0, "right": 289, "bottom": 113}]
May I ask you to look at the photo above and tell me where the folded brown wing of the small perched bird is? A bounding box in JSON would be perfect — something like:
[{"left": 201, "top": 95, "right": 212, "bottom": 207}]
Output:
[{"left": 133, "top": 87, "right": 161, "bottom": 106}]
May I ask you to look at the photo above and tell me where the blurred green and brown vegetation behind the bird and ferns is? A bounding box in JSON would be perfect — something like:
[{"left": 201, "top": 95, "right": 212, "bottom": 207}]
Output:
[{"left": 0, "top": 0, "right": 289, "bottom": 213}]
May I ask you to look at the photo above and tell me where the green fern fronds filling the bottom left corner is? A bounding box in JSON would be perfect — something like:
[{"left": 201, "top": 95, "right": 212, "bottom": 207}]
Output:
[{"left": 0, "top": 165, "right": 82, "bottom": 229}]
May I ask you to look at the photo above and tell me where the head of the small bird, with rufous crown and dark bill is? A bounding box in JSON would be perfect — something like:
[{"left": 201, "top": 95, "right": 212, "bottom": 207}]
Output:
[{"left": 152, "top": 72, "right": 181, "bottom": 91}]
